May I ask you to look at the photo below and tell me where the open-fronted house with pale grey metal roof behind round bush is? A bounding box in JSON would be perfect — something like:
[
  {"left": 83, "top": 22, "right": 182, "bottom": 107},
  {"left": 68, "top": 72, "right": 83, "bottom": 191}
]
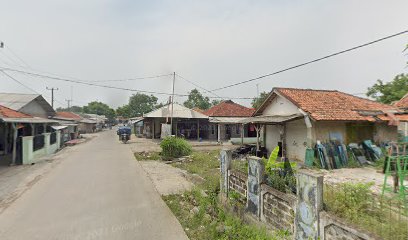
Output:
[{"left": 143, "top": 103, "right": 209, "bottom": 139}]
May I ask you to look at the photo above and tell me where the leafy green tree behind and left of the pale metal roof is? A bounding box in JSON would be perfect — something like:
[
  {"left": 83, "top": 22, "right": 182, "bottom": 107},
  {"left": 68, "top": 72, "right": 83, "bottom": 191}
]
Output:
[{"left": 116, "top": 93, "right": 163, "bottom": 118}]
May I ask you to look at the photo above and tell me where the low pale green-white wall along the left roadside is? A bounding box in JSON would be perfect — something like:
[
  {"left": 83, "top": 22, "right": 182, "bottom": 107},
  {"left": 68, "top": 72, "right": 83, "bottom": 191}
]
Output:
[{"left": 22, "top": 131, "right": 61, "bottom": 164}]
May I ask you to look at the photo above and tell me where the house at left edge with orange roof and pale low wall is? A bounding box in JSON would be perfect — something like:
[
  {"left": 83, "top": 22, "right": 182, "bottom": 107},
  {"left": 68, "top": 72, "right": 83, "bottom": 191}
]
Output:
[{"left": 0, "top": 105, "right": 60, "bottom": 165}]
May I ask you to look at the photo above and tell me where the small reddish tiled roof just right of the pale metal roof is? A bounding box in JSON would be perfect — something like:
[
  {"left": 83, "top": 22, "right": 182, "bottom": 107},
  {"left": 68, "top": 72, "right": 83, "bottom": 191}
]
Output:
[{"left": 204, "top": 100, "right": 255, "bottom": 117}]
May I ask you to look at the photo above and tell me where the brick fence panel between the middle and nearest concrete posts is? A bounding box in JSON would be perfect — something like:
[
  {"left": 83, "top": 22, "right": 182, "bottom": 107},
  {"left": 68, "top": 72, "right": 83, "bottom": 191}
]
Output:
[{"left": 261, "top": 184, "right": 296, "bottom": 233}]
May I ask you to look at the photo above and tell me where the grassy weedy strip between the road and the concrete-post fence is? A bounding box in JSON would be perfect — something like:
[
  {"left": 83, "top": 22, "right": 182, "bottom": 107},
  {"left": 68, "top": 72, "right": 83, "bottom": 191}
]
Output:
[{"left": 163, "top": 150, "right": 289, "bottom": 240}]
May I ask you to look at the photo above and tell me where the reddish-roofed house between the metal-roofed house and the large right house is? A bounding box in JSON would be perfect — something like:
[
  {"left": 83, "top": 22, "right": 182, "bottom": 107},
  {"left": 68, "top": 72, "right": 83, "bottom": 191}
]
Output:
[{"left": 203, "top": 100, "right": 256, "bottom": 142}]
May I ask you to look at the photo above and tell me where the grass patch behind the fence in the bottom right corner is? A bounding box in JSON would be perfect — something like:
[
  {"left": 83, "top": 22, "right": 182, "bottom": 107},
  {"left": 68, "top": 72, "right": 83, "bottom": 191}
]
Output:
[{"left": 324, "top": 183, "right": 408, "bottom": 240}]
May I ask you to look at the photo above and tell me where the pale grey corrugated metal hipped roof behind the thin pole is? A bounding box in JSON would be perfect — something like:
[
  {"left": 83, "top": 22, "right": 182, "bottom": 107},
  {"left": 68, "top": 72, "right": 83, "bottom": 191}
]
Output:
[{"left": 143, "top": 103, "right": 208, "bottom": 119}]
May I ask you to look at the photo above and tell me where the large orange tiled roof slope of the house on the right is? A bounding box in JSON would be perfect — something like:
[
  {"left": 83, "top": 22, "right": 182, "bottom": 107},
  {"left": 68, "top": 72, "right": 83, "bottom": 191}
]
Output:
[{"left": 275, "top": 88, "right": 396, "bottom": 121}]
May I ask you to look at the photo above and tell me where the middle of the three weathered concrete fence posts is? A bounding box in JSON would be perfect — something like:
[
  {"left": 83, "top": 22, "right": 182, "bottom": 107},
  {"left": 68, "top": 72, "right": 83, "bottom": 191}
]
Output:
[{"left": 247, "top": 157, "right": 264, "bottom": 219}]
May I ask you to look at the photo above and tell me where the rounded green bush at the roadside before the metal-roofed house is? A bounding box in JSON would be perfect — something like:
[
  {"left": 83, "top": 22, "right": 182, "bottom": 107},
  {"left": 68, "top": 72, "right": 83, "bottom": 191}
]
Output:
[{"left": 160, "top": 137, "right": 193, "bottom": 158}]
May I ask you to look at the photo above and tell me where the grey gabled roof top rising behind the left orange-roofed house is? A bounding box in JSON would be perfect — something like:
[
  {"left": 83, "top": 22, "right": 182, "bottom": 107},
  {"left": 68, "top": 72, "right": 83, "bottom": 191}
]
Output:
[{"left": 0, "top": 93, "right": 55, "bottom": 118}]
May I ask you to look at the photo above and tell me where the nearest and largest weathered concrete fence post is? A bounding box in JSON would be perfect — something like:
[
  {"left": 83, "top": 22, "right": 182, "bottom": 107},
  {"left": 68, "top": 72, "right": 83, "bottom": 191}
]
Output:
[{"left": 295, "top": 170, "right": 323, "bottom": 239}]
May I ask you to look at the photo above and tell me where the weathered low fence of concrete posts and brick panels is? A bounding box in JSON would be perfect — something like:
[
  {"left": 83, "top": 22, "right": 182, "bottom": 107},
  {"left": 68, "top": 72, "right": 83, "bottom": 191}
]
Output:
[{"left": 220, "top": 150, "right": 377, "bottom": 240}]
